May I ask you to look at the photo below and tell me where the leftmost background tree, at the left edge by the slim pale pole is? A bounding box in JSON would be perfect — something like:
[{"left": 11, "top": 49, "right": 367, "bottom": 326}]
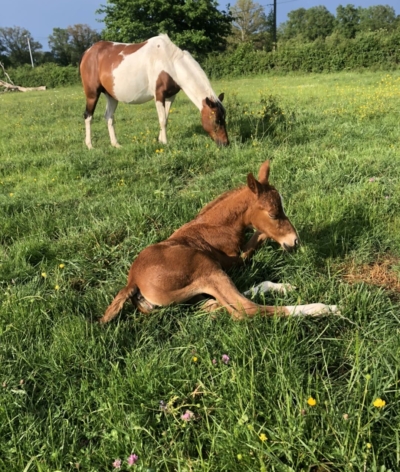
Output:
[{"left": 0, "top": 26, "right": 42, "bottom": 66}]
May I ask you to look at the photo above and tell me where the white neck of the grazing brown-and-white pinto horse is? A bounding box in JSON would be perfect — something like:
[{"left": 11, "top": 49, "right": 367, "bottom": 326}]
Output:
[{"left": 175, "top": 54, "right": 216, "bottom": 110}]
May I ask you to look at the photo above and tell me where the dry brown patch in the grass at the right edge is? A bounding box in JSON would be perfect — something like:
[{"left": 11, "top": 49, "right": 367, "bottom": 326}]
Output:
[{"left": 342, "top": 254, "right": 400, "bottom": 293}]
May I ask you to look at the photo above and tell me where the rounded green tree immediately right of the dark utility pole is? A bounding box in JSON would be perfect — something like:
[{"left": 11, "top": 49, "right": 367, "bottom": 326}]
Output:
[{"left": 279, "top": 5, "right": 335, "bottom": 41}]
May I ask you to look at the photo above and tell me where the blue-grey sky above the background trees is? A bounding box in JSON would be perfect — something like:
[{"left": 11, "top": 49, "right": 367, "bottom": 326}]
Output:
[{"left": 0, "top": 0, "right": 400, "bottom": 50}]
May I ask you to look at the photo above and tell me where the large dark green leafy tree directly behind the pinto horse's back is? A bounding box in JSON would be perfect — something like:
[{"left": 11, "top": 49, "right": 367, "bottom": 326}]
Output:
[{"left": 97, "top": 0, "right": 232, "bottom": 56}]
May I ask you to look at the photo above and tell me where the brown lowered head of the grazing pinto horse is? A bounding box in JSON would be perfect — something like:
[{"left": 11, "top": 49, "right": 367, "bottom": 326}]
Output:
[{"left": 201, "top": 93, "right": 229, "bottom": 146}]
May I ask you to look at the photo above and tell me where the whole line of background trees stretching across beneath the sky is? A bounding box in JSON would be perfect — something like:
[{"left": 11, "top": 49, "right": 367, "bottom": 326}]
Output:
[{"left": 0, "top": 0, "right": 400, "bottom": 67}]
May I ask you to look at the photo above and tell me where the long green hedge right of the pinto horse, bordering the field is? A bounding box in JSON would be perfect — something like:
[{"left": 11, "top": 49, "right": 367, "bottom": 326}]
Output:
[{"left": 203, "top": 31, "right": 400, "bottom": 78}]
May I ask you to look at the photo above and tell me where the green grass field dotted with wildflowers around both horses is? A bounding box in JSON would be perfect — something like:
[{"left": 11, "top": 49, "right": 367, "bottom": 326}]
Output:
[{"left": 0, "top": 71, "right": 400, "bottom": 472}]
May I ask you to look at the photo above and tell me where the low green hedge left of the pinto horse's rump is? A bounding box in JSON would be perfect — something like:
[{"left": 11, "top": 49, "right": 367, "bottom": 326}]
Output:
[{"left": 2, "top": 62, "right": 80, "bottom": 88}]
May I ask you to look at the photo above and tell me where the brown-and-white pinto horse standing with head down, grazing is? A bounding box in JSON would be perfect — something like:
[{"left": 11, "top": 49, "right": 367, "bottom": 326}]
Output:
[{"left": 80, "top": 34, "right": 229, "bottom": 149}]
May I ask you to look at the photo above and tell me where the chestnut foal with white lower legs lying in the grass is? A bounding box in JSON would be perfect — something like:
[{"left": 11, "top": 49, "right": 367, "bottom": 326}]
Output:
[{"left": 100, "top": 161, "right": 337, "bottom": 323}]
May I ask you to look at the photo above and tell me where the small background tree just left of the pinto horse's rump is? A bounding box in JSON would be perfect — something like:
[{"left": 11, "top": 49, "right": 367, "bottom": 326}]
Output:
[{"left": 49, "top": 24, "right": 100, "bottom": 66}]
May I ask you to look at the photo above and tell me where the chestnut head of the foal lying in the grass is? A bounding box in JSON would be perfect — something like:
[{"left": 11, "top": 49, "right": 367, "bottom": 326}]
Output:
[{"left": 247, "top": 161, "right": 299, "bottom": 250}]
